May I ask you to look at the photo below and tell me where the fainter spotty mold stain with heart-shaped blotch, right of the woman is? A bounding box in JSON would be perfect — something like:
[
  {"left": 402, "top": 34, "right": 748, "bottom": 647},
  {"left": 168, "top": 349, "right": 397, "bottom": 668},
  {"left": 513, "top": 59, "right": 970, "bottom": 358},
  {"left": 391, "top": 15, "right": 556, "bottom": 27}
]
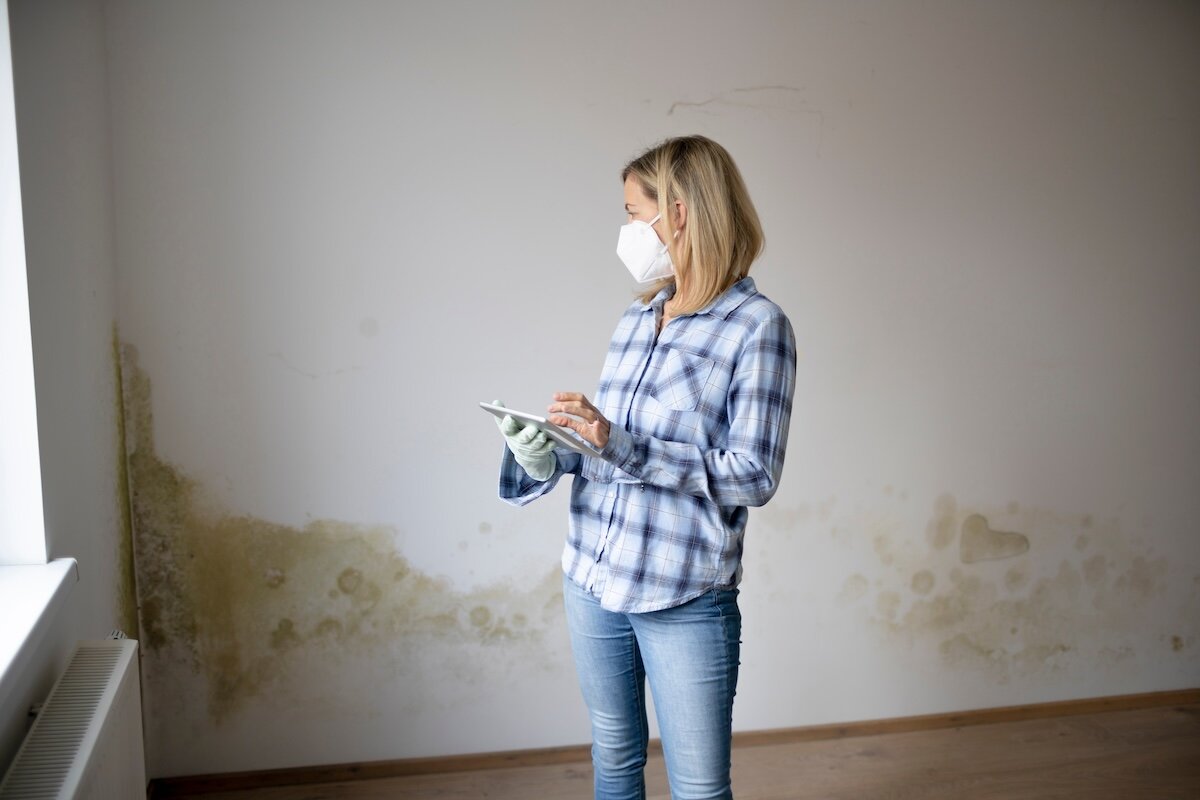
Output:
[{"left": 835, "top": 494, "right": 1198, "bottom": 684}]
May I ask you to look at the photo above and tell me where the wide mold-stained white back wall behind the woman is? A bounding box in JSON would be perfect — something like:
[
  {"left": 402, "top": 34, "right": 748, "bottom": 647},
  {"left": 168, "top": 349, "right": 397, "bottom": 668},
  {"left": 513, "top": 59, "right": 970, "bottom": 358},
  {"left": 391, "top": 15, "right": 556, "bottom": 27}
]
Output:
[{"left": 18, "top": 0, "right": 1200, "bottom": 776}]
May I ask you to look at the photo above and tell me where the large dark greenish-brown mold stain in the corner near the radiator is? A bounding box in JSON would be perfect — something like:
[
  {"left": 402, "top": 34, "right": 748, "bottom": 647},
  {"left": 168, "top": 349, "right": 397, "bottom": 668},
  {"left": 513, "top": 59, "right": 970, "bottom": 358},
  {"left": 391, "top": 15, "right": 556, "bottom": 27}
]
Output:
[{"left": 121, "top": 344, "right": 562, "bottom": 722}]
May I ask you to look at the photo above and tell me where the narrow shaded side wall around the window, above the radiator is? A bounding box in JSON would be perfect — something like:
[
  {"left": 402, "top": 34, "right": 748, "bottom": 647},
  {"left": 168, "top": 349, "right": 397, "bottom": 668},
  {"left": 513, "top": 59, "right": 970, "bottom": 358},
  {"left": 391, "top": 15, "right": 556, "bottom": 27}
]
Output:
[{"left": 0, "top": 0, "right": 137, "bottom": 777}]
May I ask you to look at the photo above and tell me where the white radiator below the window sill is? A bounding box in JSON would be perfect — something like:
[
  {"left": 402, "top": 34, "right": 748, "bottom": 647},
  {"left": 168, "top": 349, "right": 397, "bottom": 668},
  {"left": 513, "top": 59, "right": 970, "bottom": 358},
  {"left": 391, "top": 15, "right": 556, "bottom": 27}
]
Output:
[{"left": 0, "top": 639, "right": 146, "bottom": 800}]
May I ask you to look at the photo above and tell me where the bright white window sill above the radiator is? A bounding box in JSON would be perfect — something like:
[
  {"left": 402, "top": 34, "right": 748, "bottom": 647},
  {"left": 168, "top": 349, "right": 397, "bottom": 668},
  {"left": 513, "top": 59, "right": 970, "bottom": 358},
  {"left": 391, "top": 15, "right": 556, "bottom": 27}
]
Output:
[{"left": 0, "top": 558, "right": 79, "bottom": 696}]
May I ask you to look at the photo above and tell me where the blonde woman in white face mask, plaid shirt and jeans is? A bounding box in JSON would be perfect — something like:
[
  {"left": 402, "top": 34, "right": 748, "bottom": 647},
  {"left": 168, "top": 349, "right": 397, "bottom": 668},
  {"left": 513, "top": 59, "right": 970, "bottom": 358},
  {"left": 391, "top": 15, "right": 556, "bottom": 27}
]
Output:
[{"left": 499, "top": 136, "right": 796, "bottom": 800}]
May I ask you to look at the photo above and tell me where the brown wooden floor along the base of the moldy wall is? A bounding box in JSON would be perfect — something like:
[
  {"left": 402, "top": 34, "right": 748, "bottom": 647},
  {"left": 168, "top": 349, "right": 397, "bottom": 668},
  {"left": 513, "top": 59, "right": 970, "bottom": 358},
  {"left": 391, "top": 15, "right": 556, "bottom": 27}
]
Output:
[{"left": 174, "top": 704, "right": 1200, "bottom": 800}]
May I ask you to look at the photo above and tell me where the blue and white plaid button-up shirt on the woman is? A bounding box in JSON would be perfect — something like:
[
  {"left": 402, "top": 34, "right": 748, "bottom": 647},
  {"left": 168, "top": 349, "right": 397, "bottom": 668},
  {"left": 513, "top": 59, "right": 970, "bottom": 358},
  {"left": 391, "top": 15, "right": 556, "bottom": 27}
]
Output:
[{"left": 499, "top": 278, "right": 796, "bottom": 613}]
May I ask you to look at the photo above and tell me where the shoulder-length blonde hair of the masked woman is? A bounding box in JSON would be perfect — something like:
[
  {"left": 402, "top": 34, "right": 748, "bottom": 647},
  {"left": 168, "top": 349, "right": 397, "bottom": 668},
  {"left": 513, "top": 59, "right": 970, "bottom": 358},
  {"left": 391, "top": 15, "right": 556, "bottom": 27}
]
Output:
[{"left": 620, "top": 136, "right": 764, "bottom": 313}]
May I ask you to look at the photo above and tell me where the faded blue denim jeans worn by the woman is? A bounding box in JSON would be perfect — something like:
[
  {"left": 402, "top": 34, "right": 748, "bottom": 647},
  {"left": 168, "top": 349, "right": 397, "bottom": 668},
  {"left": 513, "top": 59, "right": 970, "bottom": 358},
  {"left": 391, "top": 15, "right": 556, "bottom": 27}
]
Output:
[{"left": 563, "top": 576, "right": 742, "bottom": 800}]
